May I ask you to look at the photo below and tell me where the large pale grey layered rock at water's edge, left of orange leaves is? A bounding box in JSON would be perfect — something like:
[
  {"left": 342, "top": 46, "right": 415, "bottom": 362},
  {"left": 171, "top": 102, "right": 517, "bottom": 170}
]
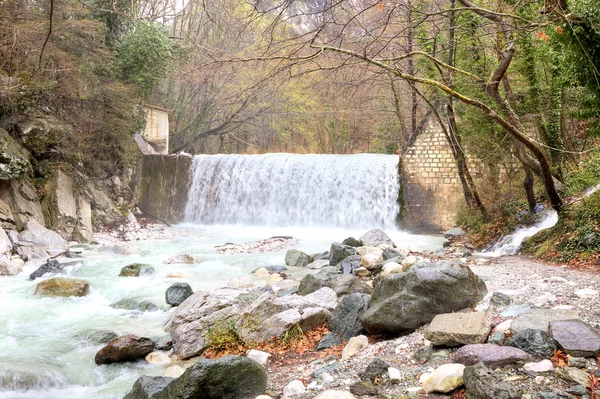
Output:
[{"left": 165, "top": 288, "right": 247, "bottom": 359}]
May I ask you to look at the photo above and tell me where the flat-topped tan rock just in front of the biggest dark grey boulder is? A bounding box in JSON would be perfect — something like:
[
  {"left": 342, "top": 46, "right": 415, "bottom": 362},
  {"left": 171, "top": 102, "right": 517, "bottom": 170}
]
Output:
[{"left": 425, "top": 312, "right": 491, "bottom": 346}]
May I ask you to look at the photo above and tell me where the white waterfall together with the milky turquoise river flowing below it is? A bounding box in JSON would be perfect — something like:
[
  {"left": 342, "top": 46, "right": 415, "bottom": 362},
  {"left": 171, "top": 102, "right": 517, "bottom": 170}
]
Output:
[{"left": 0, "top": 154, "right": 442, "bottom": 399}]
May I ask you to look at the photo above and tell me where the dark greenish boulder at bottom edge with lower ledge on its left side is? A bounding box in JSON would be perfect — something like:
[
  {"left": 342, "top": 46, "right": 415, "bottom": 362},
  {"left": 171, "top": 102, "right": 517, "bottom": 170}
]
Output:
[{"left": 123, "top": 356, "right": 267, "bottom": 399}]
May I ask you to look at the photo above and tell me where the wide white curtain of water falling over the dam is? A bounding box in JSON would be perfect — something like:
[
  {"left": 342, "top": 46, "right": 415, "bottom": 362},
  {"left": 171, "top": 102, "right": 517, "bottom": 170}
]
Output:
[{"left": 185, "top": 153, "right": 400, "bottom": 228}]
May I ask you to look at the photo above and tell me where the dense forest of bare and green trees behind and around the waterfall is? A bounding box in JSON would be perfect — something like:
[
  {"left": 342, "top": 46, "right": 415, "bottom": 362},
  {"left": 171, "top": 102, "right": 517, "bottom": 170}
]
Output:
[{"left": 0, "top": 0, "right": 600, "bottom": 258}]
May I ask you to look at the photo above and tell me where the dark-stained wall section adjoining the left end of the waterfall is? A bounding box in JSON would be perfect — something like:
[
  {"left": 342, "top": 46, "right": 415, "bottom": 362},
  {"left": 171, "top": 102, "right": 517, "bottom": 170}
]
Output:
[{"left": 136, "top": 155, "right": 192, "bottom": 223}]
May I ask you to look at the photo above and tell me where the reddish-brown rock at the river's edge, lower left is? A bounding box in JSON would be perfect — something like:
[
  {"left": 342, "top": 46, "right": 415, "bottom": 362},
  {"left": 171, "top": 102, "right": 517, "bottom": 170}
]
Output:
[{"left": 94, "top": 334, "right": 155, "bottom": 365}]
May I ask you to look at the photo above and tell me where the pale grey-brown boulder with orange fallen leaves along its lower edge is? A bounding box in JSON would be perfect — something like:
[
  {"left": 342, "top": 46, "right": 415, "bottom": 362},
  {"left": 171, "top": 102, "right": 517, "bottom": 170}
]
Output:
[{"left": 236, "top": 287, "right": 337, "bottom": 342}]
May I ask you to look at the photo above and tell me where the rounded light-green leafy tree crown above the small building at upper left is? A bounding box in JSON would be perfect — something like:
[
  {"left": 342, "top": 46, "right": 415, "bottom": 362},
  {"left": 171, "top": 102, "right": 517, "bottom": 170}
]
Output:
[{"left": 115, "top": 21, "right": 176, "bottom": 96}]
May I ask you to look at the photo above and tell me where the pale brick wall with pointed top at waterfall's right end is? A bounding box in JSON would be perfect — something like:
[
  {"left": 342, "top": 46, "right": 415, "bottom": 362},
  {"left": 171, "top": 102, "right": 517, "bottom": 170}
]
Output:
[{"left": 400, "top": 115, "right": 465, "bottom": 233}]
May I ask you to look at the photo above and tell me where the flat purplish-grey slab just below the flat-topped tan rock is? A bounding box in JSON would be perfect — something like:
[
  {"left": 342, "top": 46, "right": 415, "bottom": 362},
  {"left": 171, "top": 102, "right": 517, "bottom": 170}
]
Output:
[{"left": 452, "top": 344, "right": 532, "bottom": 369}]
